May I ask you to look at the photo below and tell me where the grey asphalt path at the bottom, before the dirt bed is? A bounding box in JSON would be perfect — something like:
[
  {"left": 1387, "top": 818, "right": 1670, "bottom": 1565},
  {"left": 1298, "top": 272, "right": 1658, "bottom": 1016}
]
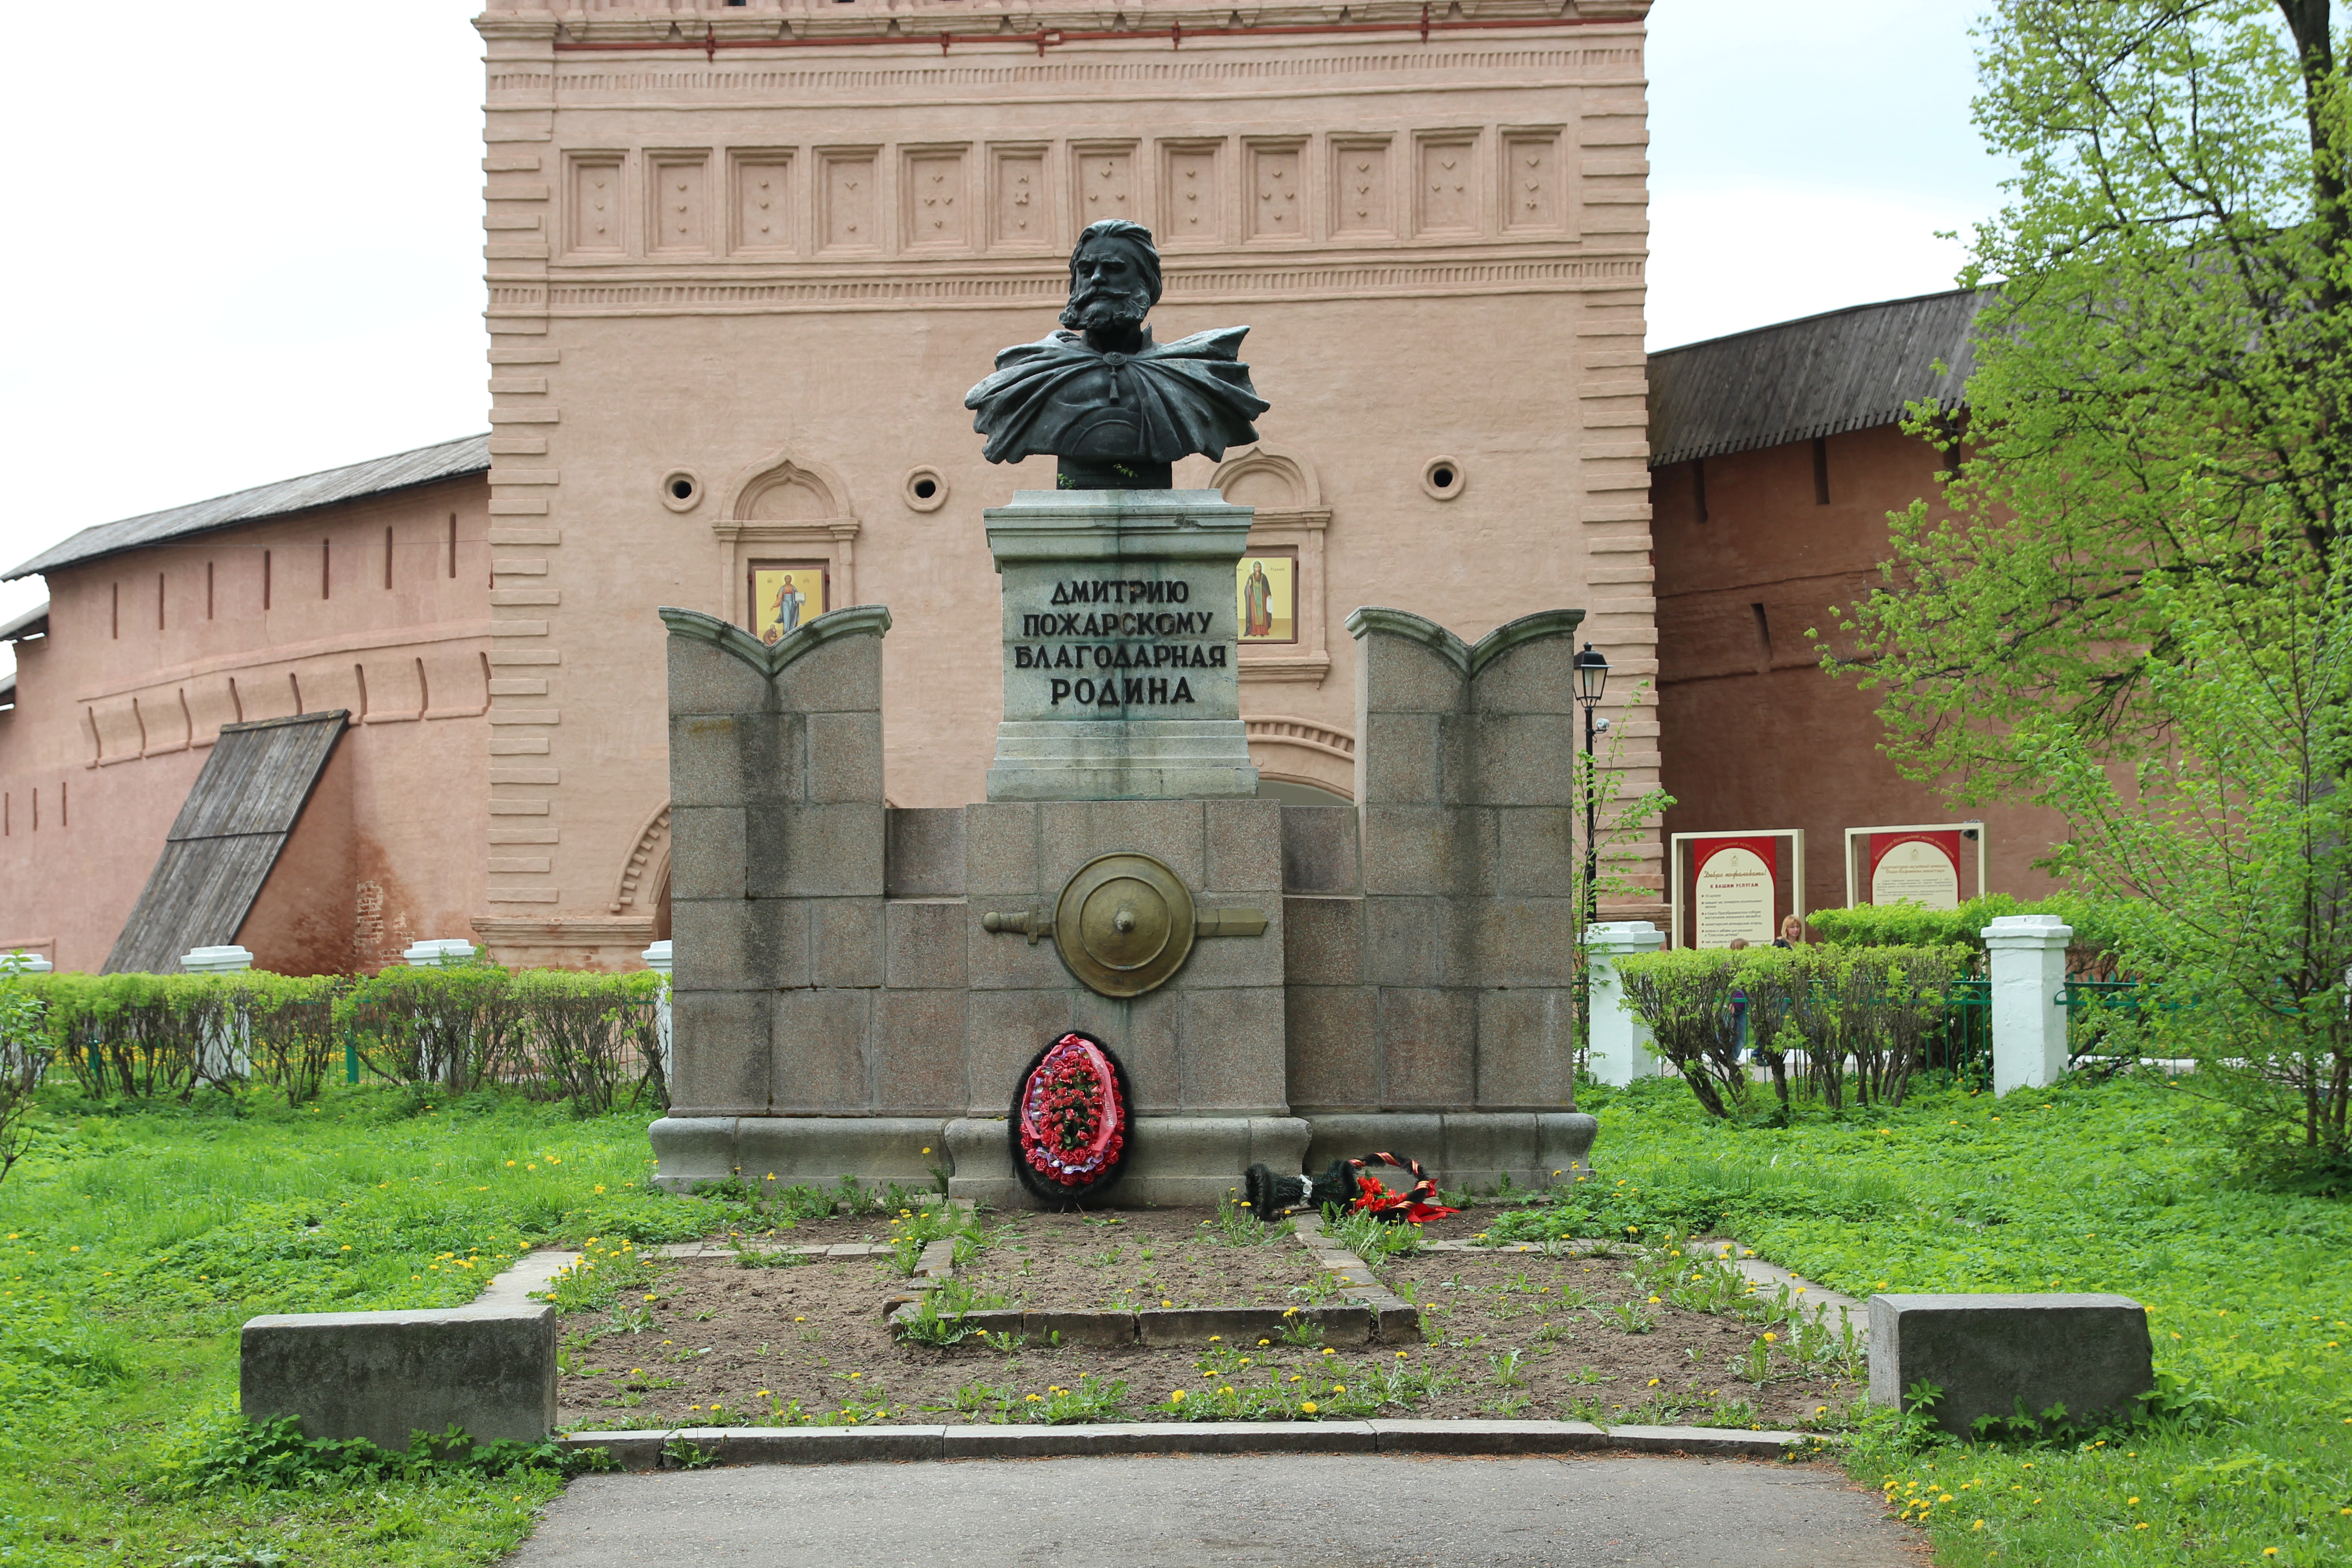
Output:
[{"left": 508, "top": 1455, "right": 1926, "bottom": 1568}]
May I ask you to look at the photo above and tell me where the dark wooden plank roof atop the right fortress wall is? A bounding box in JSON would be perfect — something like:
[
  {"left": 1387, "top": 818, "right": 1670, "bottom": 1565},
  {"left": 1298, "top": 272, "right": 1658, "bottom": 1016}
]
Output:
[{"left": 1649, "top": 289, "right": 1985, "bottom": 468}]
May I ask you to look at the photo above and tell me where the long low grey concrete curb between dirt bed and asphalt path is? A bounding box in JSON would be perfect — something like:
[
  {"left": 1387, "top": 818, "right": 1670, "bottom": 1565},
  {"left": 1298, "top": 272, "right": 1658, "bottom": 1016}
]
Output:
[{"left": 558, "top": 1420, "right": 1839, "bottom": 1469}]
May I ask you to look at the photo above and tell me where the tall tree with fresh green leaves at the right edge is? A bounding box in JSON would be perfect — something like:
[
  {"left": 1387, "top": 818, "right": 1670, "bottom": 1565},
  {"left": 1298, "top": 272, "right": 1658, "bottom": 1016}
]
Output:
[{"left": 1842, "top": 0, "right": 2352, "bottom": 1171}]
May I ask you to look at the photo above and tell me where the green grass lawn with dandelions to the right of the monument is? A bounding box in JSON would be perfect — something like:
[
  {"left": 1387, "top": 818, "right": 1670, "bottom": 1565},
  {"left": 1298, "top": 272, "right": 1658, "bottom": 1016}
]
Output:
[{"left": 1494, "top": 1077, "right": 2352, "bottom": 1568}]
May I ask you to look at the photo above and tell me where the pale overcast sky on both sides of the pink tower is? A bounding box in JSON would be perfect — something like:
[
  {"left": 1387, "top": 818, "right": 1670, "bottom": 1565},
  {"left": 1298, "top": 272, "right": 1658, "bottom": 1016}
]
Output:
[{"left": 0, "top": 0, "right": 1999, "bottom": 668}]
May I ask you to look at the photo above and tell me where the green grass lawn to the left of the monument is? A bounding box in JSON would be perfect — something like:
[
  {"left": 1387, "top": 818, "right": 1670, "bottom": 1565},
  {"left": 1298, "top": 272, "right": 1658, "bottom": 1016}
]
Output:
[{"left": 0, "top": 1091, "right": 715, "bottom": 1568}]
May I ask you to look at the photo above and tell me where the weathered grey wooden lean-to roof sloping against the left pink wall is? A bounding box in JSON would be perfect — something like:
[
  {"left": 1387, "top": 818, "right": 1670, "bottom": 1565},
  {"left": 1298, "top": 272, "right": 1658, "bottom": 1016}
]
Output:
[{"left": 103, "top": 708, "right": 350, "bottom": 975}]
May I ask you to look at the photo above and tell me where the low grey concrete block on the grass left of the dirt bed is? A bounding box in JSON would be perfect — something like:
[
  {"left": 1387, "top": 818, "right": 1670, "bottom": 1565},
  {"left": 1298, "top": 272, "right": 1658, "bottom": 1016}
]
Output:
[{"left": 240, "top": 1303, "right": 555, "bottom": 1450}]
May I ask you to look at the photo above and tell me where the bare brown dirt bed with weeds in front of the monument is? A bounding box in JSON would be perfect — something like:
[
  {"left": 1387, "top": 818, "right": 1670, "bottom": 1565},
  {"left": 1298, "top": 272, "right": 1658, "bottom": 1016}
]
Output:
[{"left": 562, "top": 1210, "right": 1861, "bottom": 1429}]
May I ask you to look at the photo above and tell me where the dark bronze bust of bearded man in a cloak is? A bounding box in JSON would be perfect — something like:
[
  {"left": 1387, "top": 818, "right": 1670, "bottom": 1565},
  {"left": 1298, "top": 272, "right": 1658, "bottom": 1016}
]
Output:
[{"left": 964, "top": 219, "right": 1268, "bottom": 489}]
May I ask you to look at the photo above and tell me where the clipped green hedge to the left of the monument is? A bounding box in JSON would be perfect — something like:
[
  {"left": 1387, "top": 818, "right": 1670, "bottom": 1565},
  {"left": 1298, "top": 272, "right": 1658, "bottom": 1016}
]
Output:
[{"left": 7, "top": 964, "right": 670, "bottom": 1117}]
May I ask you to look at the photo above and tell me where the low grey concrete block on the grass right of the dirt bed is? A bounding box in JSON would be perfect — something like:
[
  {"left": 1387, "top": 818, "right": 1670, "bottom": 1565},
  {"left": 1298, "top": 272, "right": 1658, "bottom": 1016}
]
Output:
[{"left": 1870, "top": 1293, "right": 2157, "bottom": 1436}]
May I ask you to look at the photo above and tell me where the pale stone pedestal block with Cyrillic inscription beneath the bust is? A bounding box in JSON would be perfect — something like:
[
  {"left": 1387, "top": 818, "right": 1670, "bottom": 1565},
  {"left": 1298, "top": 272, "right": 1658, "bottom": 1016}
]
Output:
[{"left": 985, "top": 489, "right": 1258, "bottom": 799}]
